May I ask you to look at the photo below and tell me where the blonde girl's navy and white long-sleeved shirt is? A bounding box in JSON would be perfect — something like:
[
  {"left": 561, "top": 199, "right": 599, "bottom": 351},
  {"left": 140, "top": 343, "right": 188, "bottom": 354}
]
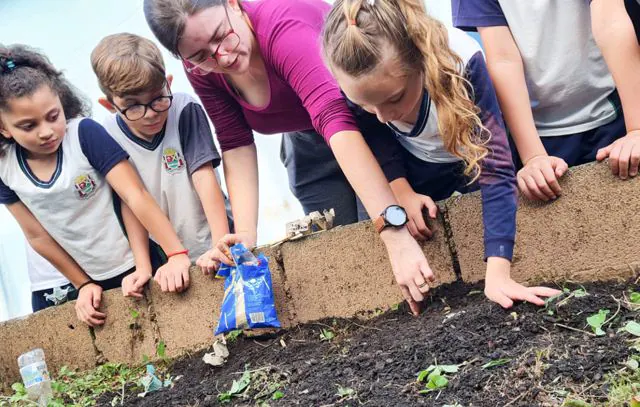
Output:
[{"left": 350, "top": 28, "right": 518, "bottom": 260}]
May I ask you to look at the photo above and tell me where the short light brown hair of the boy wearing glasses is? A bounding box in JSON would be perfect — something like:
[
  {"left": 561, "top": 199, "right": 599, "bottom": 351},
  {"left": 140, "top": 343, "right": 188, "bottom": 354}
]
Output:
[{"left": 91, "top": 33, "right": 166, "bottom": 100}]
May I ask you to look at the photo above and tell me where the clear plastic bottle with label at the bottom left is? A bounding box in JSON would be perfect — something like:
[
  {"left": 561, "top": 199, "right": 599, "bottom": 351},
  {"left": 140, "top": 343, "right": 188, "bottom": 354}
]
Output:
[{"left": 18, "top": 349, "right": 52, "bottom": 407}]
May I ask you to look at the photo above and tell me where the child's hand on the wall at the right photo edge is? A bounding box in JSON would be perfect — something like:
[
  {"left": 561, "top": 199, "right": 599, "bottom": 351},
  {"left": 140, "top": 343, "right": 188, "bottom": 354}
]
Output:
[{"left": 596, "top": 130, "right": 640, "bottom": 179}]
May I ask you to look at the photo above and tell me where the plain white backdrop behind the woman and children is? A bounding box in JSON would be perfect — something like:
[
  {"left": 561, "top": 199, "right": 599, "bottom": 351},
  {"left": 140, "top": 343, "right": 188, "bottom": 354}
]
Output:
[{"left": 0, "top": 0, "right": 451, "bottom": 321}]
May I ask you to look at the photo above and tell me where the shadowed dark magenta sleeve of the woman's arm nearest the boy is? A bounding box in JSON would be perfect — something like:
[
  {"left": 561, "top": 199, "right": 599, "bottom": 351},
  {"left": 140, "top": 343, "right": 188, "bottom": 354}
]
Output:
[{"left": 187, "top": 73, "right": 254, "bottom": 152}]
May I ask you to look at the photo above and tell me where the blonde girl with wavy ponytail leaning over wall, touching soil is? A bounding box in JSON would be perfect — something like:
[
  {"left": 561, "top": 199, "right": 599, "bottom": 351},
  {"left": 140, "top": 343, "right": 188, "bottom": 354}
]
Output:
[{"left": 323, "top": 0, "right": 558, "bottom": 308}]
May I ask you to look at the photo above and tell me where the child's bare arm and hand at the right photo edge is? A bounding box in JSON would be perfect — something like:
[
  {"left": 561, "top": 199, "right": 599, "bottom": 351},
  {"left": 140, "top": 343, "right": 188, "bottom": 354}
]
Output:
[{"left": 591, "top": 0, "right": 640, "bottom": 178}]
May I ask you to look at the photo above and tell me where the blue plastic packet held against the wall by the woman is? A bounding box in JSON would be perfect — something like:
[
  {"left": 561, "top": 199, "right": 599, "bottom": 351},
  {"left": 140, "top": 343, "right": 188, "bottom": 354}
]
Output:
[{"left": 215, "top": 244, "right": 280, "bottom": 335}]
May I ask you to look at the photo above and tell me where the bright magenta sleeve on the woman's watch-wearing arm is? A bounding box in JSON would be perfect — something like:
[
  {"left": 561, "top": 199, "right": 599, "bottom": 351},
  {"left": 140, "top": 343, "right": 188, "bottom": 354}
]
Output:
[{"left": 267, "top": 10, "right": 359, "bottom": 143}]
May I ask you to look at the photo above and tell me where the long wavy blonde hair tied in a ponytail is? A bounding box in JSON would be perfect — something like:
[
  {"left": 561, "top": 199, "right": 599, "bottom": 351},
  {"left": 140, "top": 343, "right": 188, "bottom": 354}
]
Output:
[{"left": 323, "top": 0, "right": 490, "bottom": 182}]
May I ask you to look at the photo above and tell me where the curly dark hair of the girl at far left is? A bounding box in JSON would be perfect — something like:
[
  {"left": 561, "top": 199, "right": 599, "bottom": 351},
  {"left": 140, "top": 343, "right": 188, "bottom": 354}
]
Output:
[{"left": 0, "top": 44, "right": 91, "bottom": 154}]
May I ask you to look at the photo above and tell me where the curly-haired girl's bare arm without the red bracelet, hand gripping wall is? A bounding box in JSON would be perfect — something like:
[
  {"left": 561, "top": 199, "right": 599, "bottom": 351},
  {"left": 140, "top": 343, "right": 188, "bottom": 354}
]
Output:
[{"left": 7, "top": 201, "right": 106, "bottom": 326}]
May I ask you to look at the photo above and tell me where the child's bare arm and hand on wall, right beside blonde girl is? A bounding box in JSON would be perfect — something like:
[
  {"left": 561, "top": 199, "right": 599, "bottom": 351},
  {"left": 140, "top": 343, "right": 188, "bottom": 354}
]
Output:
[{"left": 478, "top": 26, "right": 567, "bottom": 201}]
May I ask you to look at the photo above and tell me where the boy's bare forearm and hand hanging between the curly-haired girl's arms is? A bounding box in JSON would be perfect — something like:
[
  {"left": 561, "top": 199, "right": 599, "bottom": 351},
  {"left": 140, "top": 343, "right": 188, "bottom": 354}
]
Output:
[{"left": 122, "top": 203, "right": 152, "bottom": 298}]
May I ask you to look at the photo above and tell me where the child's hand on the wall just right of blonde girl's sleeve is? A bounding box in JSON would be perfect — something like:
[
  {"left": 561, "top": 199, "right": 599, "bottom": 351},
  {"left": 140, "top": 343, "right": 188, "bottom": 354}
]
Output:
[{"left": 517, "top": 155, "right": 569, "bottom": 201}]
